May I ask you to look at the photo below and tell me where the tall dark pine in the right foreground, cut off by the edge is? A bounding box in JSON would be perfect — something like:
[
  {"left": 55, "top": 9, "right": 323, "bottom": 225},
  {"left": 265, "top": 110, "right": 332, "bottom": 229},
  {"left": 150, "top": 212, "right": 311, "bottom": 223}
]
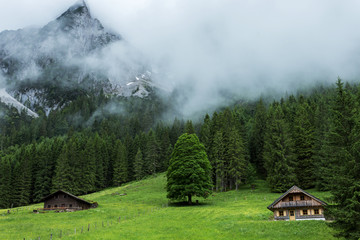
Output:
[{"left": 328, "top": 79, "right": 360, "bottom": 240}]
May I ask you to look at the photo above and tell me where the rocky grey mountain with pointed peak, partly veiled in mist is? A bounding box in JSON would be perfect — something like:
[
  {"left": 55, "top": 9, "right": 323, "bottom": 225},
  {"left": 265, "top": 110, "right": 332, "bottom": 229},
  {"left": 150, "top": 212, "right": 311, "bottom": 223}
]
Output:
[{"left": 0, "top": 1, "right": 153, "bottom": 116}]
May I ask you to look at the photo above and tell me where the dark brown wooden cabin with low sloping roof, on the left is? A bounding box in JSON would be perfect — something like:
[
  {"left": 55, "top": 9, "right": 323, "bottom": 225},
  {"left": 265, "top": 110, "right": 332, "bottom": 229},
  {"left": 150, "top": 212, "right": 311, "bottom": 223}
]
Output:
[{"left": 42, "top": 190, "right": 97, "bottom": 211}]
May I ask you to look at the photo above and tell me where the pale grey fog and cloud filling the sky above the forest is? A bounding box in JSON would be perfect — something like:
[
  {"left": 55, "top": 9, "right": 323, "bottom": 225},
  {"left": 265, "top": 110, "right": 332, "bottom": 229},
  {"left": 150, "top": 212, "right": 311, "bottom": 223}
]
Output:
[{"left": 0, "top": 0, "right": 360, "bottom": 116}]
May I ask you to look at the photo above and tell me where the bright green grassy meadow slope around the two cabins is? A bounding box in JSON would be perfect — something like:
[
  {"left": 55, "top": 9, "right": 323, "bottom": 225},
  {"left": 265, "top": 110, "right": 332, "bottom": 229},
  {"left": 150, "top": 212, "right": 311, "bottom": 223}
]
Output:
[{"left": 0, "top": 175, "right": 334, "bottom": 240}]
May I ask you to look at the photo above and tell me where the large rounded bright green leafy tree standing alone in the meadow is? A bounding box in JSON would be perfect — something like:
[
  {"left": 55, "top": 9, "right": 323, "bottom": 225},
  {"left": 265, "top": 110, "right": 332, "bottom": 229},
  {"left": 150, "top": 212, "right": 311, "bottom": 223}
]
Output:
[{"left": 166, "top": 133, "right": 213, "bottom": 204}]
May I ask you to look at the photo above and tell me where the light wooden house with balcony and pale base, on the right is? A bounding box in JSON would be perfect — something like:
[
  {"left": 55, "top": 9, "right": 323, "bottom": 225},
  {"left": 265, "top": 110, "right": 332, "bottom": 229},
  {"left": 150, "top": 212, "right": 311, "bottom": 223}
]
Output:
[{"left": 268, "top": 186, "right": 327, "bottom": 221}]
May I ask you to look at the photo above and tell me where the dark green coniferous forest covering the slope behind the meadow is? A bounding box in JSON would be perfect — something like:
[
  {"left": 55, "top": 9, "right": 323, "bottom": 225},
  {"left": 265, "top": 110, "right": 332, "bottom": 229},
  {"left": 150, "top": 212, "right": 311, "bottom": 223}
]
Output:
[{"left": 0, "top": 79, "right": 360, "bottom": 239}]
